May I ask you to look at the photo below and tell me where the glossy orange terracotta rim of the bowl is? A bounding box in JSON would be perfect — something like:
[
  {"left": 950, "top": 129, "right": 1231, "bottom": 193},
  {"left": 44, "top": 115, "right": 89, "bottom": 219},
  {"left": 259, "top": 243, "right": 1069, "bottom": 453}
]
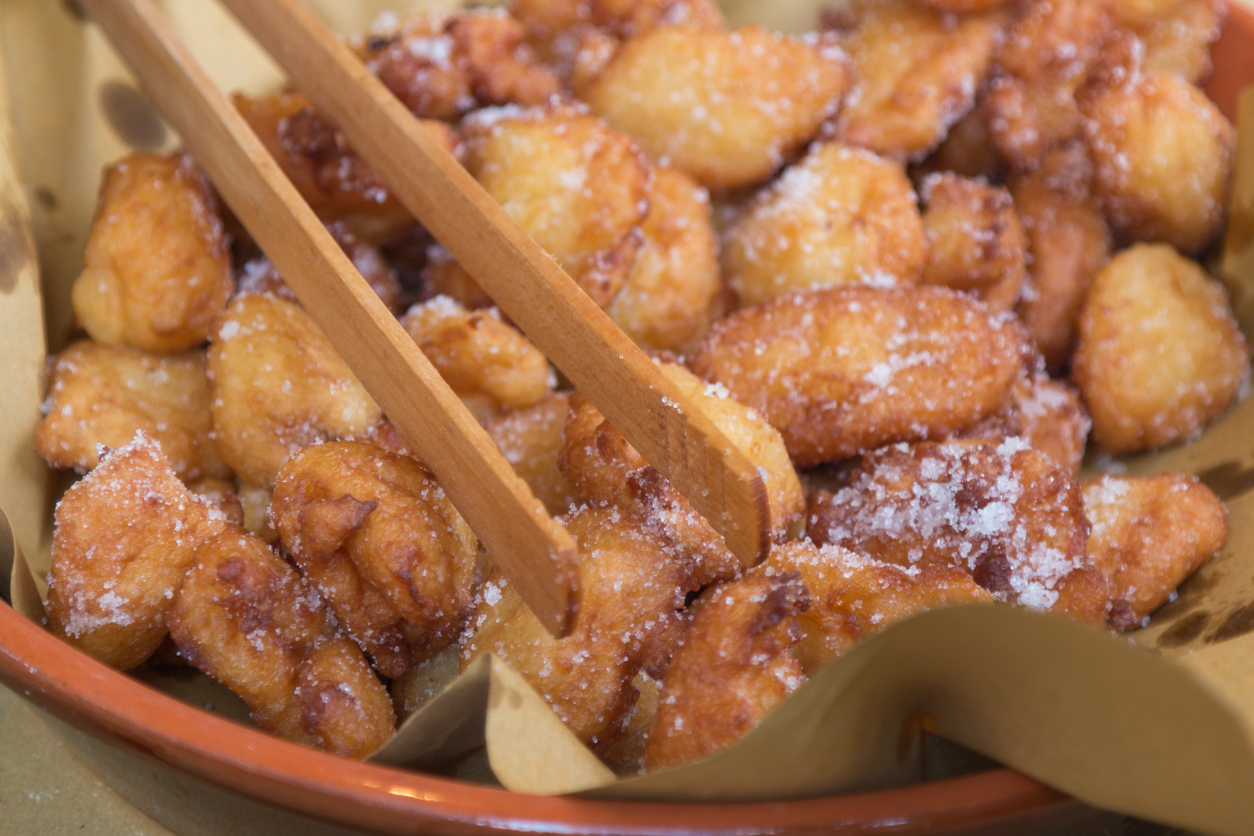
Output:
[{"left": 0, "top": 6, "right": 1254, "bottom": 836}]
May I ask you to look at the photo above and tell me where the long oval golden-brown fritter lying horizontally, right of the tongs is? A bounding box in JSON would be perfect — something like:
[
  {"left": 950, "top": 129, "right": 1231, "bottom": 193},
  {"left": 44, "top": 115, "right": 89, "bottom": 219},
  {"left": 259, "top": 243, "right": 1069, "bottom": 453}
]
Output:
[{"left": 690, "top": 287, "right": 1027, "bottom": 468}]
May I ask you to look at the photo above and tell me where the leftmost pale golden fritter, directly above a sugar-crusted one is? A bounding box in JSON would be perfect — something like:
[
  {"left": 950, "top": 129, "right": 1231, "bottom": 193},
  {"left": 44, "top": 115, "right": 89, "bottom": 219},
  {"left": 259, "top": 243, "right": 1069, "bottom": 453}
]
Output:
[{"left": 35, "top": 340, "right": 231, "bottom": 480}]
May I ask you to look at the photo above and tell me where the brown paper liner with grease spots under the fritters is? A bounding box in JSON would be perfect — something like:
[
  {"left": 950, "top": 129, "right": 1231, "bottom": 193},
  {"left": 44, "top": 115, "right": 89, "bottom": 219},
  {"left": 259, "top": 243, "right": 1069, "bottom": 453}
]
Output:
[{"left": 7, "top": 0, "right": 1254, "bottom": 833}]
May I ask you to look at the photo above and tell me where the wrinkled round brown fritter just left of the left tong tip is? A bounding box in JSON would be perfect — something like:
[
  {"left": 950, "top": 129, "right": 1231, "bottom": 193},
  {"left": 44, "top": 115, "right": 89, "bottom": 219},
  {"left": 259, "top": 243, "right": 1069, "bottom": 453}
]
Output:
[{"left": 271, "top": 441, "right": 478, "bottom": 677}]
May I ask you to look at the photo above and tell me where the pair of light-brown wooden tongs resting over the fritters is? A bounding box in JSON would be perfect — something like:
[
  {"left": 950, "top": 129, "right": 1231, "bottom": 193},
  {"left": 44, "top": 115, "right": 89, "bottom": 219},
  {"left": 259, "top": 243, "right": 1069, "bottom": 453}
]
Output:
[{"left": 82, "top": 0, "right": 769, "bottom": 635}]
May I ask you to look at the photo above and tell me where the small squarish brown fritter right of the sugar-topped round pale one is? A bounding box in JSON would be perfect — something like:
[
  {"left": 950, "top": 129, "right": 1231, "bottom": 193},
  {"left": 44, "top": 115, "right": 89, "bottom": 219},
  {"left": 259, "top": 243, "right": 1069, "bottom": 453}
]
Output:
[{"left": 919, "top": 174, "right": 1027, "bottom": 312}]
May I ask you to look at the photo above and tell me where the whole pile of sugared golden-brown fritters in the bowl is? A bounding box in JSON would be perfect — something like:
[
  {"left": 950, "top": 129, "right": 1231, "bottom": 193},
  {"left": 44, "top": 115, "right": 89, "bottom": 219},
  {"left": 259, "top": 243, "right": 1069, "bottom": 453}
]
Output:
[{"left": 35, "top": 0, "right": 1250, "bottom": 772}]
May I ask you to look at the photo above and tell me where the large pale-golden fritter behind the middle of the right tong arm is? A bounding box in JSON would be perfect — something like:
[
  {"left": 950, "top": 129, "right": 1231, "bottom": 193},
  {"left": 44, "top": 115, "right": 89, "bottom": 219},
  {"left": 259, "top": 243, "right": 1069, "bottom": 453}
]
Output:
[{"left": 424, "top": 107, "right": 650, "bottom": 307}]
